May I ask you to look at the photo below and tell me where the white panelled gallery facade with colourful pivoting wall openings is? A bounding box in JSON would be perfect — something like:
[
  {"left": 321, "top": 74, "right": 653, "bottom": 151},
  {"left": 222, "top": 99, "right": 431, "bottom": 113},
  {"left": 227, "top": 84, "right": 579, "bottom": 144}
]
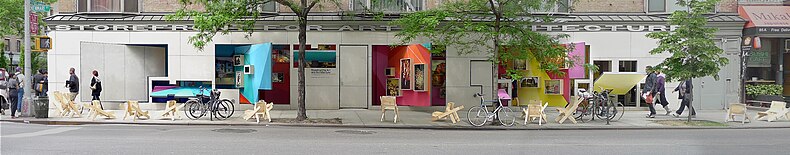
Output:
[{"left": 45, "top": 1, "right": 745, "bottom": 109}]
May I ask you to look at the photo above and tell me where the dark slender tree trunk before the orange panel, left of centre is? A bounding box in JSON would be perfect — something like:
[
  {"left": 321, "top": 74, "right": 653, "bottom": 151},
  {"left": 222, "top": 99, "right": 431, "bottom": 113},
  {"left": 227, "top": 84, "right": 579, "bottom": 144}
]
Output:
[{"left": 296, "top": 12, "right": 307, "bottom": 121}]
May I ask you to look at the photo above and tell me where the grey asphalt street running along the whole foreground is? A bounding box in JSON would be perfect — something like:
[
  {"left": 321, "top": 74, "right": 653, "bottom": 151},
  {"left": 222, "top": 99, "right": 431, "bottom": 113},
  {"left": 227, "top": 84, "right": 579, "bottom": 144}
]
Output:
[{"left": 0, "top": 122, "right": 790, "bottom": 155}]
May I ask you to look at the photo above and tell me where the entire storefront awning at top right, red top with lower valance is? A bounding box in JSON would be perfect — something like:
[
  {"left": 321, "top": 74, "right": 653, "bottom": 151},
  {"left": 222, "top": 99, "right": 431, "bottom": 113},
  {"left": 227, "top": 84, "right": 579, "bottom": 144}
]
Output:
[{"left": 738, "top": 6, "right": 790, "bottom": 35}]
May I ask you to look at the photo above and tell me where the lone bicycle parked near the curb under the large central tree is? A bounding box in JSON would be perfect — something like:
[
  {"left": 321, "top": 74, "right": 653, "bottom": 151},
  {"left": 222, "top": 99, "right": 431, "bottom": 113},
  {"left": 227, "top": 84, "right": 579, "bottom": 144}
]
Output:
[{"left": 466, "top": 93, "right": 516, "bottom": 127}]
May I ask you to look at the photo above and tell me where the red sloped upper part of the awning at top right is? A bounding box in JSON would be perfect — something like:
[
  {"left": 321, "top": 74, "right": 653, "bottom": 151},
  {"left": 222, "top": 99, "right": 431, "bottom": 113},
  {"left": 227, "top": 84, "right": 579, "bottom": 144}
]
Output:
[{"left": 738, "top": 6, "right": 790, "bottom": 28}]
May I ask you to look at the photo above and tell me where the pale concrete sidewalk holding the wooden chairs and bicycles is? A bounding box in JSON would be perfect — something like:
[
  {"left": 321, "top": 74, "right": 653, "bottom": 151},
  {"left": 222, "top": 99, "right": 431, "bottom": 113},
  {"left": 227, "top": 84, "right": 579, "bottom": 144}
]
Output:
[{"left": 0, "top": 107, "right": 790, "bottom": 130}]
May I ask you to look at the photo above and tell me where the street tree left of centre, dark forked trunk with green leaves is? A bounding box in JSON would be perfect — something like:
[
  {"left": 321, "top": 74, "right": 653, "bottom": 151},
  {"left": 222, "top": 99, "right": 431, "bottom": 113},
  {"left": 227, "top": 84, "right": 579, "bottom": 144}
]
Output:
[{"left": 167, "top": 0, "right": 340, "bottom": 120}]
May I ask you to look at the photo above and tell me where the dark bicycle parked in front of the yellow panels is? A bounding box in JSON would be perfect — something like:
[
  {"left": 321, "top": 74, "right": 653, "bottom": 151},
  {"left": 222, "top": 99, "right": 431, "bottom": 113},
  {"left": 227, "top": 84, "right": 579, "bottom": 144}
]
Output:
[{"left": 573, "top": 87, "right": 625, "bottom": 125}]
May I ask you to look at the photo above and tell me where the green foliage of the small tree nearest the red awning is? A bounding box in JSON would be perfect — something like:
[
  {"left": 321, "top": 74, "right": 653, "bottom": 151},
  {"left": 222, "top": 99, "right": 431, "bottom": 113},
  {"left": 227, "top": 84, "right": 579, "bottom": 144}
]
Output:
[{"left": 647, "top": 0, "right": 729, "bottom": 81}]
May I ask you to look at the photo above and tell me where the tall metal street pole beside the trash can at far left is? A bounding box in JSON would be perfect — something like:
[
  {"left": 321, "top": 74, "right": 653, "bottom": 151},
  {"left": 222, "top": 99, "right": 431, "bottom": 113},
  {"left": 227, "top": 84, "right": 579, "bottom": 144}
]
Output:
[{"left": 22, "top": 0, "right": 33, "bottom": 116}]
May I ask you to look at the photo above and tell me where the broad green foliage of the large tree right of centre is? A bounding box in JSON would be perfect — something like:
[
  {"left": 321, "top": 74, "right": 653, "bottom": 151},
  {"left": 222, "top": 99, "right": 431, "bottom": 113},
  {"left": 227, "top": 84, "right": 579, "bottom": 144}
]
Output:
[{"left": 392, "top": 0, "right": 572, "bottom": 96}]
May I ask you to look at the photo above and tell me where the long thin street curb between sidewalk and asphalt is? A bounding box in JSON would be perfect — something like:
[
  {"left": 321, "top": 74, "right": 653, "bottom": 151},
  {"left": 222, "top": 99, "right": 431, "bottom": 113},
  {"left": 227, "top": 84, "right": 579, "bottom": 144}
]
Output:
[{"left": 0, "top": 119, "right": 790, "bottom": 130}]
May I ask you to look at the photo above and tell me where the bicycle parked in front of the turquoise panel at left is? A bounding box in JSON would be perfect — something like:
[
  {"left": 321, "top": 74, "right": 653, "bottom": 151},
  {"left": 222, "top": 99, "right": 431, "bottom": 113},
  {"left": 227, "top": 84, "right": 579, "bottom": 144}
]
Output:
[{"left": 184, "top": 86, "right": 235, "bottom": 121}]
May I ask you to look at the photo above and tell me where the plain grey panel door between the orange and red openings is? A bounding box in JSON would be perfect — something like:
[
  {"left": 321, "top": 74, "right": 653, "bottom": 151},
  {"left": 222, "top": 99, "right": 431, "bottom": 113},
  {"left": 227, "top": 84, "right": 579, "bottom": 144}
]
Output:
[{"left": 338, "top": 46, "right": 370, "bottom": 108}]
